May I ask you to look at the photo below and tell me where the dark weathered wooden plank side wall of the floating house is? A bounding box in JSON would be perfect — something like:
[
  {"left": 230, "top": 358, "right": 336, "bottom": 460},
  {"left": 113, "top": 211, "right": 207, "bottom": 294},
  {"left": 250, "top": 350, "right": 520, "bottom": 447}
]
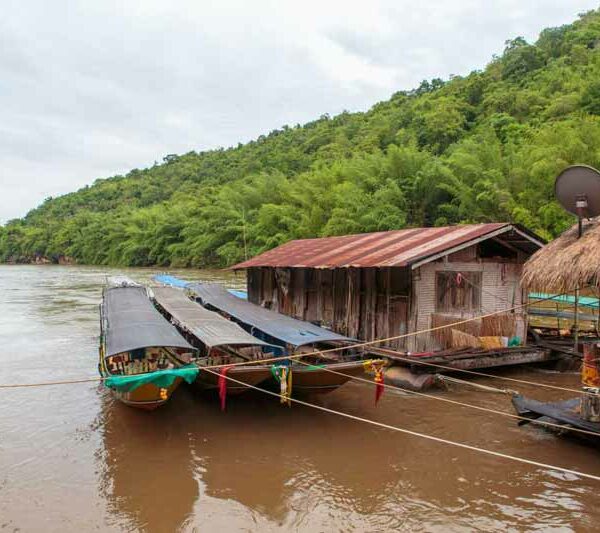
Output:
[{"left": 248, "top": 268, "right": 410, "bottom": 348}]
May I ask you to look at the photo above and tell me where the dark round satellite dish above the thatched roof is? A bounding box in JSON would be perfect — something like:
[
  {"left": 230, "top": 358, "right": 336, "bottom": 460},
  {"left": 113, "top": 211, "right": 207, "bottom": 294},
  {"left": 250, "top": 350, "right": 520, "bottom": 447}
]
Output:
[{"left": 554, "top": 165, "right": 600, "bottom": 220}]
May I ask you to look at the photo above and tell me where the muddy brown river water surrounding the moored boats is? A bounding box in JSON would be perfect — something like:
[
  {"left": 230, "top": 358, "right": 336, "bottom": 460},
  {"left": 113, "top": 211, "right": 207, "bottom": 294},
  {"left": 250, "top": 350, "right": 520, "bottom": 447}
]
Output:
[{"left": 0, "top": 265, "right": 600, "bottom": 532}]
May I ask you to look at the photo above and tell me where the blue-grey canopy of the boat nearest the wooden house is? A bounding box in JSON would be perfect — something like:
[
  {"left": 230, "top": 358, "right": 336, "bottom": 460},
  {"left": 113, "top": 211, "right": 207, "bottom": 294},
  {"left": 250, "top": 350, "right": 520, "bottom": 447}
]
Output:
[{"left": 188, "top": 283, "right": 353, "bottom": 347}]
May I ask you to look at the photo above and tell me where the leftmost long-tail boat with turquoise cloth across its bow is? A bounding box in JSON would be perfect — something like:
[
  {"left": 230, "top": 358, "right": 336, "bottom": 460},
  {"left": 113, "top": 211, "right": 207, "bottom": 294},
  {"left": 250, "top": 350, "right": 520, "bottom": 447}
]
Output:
[{"left": 98, "top": 278, "right": 198, "bottom": 410}]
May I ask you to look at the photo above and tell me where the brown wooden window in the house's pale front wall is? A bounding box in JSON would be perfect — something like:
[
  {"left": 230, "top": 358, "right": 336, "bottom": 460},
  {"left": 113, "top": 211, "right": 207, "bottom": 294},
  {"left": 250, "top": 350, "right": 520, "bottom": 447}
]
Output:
[{"left": 435, "top": 271, "right": 481, "bottom": 313}]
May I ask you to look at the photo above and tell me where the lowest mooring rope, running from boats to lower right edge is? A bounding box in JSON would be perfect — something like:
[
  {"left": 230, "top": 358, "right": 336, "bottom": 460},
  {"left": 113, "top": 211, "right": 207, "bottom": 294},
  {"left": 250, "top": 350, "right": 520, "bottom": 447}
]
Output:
[{"left": 200, "top": 370, "right": 600, "bottom": 481}]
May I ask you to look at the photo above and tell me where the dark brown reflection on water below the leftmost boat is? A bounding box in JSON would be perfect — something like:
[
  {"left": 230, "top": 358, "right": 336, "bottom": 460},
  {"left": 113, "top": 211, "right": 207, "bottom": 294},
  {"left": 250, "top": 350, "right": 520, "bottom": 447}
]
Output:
[{"left": 98, "top": 388, "right": 198, "bottom": 531}]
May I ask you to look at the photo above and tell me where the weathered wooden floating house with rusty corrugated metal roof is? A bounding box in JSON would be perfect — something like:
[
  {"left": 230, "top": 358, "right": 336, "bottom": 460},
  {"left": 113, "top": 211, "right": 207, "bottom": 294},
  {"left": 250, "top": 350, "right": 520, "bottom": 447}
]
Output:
[{"left": 232, "top": 223, "right": 544, "bottom": 352}]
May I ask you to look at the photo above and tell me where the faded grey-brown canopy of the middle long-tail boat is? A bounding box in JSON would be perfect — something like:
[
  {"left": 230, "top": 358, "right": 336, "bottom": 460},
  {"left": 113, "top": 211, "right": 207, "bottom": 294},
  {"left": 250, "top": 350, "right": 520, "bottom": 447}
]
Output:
[{"left": 152, "top": 287, "right": 271, "bottom": 348}]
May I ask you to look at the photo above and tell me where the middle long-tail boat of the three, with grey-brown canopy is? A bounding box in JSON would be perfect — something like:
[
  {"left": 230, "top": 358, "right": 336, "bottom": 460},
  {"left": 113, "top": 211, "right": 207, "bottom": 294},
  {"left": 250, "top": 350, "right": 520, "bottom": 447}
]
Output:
[{"left": 151, "top": 287, "right": 280, "bottom": 395}]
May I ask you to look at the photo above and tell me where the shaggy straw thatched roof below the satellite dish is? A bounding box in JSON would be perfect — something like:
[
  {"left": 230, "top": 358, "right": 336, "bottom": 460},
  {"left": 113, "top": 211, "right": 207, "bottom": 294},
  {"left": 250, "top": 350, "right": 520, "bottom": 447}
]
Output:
[{"left": 522, "top": 217, "right": 600, "bottom": 293}]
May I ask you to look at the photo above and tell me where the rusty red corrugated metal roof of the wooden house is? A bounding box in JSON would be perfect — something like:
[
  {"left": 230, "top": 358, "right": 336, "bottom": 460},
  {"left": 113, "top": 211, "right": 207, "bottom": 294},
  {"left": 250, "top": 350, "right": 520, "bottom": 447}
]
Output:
[{"left": 231, "top": 223, "right": 543, "bottom": 270}]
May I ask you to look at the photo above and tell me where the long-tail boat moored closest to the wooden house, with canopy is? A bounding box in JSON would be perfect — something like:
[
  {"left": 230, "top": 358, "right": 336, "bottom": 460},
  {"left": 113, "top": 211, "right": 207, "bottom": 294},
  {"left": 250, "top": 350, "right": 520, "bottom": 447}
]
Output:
[{"left": 186, "top": 283, "right": 380, "bottom": 393}]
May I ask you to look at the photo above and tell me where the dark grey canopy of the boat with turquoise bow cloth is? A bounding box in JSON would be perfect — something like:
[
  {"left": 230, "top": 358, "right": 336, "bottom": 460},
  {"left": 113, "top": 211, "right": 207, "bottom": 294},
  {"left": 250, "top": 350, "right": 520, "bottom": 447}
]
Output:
[{"left": 103, "top": 286, "right": 195, "bottom": 357}]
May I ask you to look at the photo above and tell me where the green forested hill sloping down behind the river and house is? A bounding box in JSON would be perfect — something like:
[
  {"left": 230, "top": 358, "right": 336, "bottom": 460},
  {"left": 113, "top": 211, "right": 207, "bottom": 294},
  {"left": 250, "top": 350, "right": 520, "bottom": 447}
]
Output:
[{"left": 0, "top": 10, "right": 600, "bottom": 266}]
